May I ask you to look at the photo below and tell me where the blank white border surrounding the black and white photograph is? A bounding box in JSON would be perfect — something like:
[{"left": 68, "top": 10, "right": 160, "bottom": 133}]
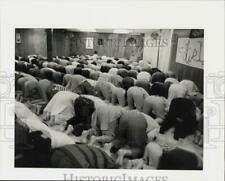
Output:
[{"left": 0, "top": 0, "right": 225, "bottom": 181}]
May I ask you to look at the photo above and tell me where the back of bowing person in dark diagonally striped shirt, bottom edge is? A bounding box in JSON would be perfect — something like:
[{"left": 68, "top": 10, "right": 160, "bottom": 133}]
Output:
[{"left": 51, "top": 144, "right": 117, "bottom": 169}]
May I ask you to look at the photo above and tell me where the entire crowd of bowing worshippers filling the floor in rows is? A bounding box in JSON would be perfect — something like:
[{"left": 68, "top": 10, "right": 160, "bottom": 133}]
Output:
[{"left": 15, "top": 55, "right": 203, "bottom": 170}]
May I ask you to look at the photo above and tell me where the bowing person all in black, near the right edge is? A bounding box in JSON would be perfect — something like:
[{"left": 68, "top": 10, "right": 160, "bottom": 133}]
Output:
[{"left": 160, "top": 98, "right": 198, "bottom": 140}]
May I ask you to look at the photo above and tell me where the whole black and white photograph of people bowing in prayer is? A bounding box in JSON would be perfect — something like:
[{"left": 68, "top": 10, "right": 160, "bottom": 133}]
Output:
[{"left": 15, "top": 28, "right": 204, "bottom": 170}]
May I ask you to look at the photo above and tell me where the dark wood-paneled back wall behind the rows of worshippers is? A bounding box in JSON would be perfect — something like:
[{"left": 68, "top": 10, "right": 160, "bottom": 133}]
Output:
[{"left": 15, "top": 29, "right": 144, "bottom": 60}]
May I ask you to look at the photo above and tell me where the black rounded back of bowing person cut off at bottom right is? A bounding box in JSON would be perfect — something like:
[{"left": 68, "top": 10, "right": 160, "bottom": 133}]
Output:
[{"left": 158, "top": 148, "right": 200, "bottom": 170}]
